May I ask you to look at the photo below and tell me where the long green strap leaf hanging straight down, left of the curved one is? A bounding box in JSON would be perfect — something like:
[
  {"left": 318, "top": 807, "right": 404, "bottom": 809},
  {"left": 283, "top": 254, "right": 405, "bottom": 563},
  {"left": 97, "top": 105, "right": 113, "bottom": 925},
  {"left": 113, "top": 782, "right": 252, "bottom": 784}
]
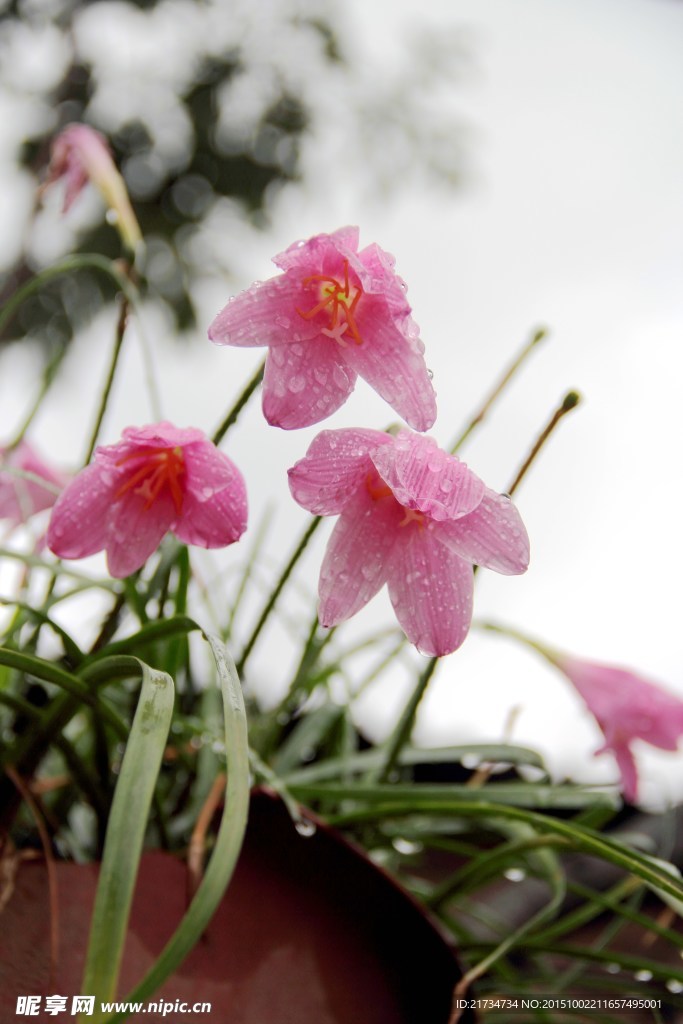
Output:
[{"left": 82, "top": 662, "right": 174, "bottom": 1021}]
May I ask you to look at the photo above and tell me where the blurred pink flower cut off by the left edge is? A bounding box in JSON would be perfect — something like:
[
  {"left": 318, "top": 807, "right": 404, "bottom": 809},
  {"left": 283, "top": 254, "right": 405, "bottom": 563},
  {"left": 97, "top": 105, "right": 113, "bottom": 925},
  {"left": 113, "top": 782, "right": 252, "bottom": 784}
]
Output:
[{"left": 0, "top": 440, "right": 67, "bottom": 525}]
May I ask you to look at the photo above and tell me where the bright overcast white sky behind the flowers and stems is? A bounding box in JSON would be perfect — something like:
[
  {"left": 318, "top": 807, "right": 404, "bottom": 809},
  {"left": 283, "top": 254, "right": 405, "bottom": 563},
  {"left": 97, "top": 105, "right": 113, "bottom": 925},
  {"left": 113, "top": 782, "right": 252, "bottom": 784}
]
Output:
[{"left": 0, "top": 0, "right": 683, "bottom": 806}]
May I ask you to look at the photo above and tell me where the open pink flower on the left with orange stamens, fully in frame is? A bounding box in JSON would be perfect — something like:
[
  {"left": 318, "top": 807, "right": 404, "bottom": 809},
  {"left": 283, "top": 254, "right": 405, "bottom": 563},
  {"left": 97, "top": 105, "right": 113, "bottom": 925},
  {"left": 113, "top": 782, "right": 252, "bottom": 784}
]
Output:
[{"left": 47, "top": 423, "right": 247, "bottom": 578}]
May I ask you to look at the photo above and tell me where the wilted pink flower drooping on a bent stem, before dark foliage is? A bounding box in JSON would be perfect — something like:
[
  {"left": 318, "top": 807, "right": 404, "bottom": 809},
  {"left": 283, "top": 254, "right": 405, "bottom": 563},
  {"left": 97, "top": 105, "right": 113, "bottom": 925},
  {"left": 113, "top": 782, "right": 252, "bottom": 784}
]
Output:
[{"left": 46, "top": 124, "right": 141, "bottom": 250}]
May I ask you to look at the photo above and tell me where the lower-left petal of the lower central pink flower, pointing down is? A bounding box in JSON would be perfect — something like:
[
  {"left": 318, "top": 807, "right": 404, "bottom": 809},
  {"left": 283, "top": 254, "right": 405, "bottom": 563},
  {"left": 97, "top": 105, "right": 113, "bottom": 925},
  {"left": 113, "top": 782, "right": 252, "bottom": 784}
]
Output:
[{"left": 318, "top": 487, "right": 402, "bottom": 626}]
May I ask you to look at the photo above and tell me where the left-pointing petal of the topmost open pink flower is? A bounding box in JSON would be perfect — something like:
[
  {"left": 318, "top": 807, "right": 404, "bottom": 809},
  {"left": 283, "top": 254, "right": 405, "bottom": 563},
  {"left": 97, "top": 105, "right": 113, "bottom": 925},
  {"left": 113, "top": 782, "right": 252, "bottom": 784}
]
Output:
[{"left": 209, "top": 273, "right": 321, "bottom": 346}]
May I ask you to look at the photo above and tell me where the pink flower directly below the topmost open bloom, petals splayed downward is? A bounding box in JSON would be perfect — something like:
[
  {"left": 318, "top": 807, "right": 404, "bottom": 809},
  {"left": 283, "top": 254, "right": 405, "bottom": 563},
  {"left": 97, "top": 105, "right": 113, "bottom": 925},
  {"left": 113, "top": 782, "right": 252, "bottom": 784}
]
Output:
[{"left": 289, "top": 430, "right": 528, "bottom": 655}]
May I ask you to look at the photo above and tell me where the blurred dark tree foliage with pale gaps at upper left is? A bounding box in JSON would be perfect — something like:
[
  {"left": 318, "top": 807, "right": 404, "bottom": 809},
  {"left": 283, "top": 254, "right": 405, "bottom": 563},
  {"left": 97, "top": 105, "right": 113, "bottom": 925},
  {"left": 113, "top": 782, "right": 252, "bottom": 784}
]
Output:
[{"left": 0, "top": 0, "right": 466, "bottom": 343}]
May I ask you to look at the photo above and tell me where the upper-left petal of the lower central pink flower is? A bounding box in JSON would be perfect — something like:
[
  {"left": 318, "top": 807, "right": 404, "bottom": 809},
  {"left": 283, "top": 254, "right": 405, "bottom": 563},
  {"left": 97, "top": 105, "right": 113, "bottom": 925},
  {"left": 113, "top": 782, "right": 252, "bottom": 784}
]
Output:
[{"left": 288, "top": 429, "right": 392, "bottom": 515}]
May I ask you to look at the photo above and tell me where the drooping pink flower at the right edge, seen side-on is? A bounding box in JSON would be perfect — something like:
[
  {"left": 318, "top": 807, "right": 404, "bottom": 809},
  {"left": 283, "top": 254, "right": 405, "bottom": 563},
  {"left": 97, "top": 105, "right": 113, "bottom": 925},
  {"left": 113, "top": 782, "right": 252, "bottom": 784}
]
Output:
[{"left": 544, "top": 651, "right": 683, "bottom": 803}]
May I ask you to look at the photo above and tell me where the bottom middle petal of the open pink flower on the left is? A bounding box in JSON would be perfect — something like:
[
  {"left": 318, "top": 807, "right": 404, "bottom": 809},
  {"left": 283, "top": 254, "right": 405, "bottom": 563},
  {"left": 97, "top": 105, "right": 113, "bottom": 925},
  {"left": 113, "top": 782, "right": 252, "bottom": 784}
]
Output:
[{"left": 105, "top": 492, "right": 175, "bottom": 579}]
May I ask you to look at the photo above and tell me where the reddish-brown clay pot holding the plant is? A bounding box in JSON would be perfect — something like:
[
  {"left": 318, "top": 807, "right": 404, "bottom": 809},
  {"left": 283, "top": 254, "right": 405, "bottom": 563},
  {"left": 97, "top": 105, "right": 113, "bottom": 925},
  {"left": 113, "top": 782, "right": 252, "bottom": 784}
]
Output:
[{"left": 0, "top": 792, "right": 467, "bottom": 1024}]
